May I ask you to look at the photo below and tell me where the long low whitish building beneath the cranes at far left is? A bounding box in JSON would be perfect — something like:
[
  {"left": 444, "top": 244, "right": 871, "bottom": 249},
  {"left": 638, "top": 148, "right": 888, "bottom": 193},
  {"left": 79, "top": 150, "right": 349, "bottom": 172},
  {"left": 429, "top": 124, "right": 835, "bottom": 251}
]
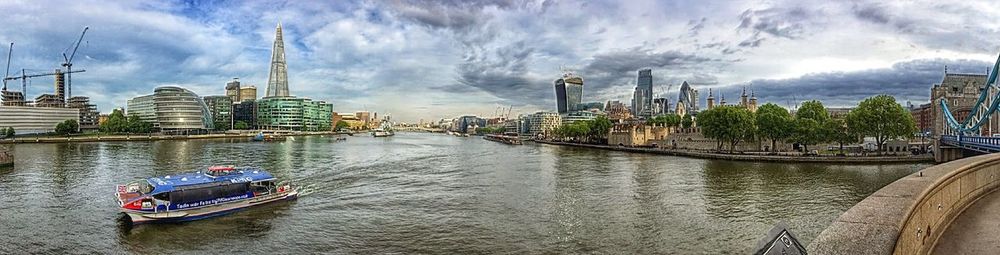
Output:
[{"left": 0, "top": 106, "right": 80, "bottom": 135}]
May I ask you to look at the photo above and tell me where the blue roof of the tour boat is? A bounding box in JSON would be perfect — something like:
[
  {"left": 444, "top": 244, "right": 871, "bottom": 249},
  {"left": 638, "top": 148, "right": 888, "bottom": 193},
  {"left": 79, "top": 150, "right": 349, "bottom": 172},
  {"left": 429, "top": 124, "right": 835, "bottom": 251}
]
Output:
[{"left": 146, "top": 167, "right": 274, "bottom": 194}]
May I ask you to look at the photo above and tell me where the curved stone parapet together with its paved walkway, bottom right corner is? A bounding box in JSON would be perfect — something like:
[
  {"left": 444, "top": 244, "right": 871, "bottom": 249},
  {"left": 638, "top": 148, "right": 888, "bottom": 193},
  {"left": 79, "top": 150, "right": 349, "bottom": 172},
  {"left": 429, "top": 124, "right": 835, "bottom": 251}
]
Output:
[{"left": 807, "top": 153, "right": 1000, "bottom": 254}]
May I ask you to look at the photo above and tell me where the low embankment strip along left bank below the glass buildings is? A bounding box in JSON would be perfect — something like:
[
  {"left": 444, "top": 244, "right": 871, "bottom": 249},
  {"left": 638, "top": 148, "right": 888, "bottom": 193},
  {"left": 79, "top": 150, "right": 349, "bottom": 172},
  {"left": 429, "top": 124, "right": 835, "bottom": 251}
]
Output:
[{"left": 0, "top": 132, "right": 353, "bottom": 144}]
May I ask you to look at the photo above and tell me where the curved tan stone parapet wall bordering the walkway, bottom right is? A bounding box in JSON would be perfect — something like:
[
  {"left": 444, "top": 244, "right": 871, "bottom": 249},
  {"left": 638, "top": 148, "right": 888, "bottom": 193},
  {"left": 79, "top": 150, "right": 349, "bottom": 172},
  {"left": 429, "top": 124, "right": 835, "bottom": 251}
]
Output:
[{"left": 808, "top": 153, "right": 1000, "bottom": 254}]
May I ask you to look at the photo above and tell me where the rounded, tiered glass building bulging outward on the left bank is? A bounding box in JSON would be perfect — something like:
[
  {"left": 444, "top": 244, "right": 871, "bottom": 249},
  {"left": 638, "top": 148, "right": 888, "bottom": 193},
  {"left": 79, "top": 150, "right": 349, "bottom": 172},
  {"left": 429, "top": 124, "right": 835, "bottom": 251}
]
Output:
[{"left": 128, "top": 86, "right": 215, "bottom": 132}]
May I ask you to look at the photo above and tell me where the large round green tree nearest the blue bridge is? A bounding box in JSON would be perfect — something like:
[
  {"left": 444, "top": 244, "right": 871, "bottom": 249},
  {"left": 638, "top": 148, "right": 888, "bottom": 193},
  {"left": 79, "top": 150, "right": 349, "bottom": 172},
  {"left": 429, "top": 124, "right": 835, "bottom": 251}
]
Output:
[{"left": 847, "top": 95, "right": 917, "bottom": 155}]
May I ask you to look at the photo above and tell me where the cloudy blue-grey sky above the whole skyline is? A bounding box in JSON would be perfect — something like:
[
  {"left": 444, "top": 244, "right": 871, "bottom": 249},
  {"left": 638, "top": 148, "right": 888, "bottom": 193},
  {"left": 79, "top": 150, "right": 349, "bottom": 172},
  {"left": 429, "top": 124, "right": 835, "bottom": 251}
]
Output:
[{"left": 0, "top": 0, "right": 1000, "bottom": 121}]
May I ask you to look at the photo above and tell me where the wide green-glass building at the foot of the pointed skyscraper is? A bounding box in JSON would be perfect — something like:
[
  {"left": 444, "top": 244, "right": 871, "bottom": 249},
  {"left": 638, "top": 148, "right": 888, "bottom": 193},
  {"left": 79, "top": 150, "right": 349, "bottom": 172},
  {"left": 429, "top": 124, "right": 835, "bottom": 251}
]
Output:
[{"left": 257, "top": 97, "right": 333, "bottom": 131}]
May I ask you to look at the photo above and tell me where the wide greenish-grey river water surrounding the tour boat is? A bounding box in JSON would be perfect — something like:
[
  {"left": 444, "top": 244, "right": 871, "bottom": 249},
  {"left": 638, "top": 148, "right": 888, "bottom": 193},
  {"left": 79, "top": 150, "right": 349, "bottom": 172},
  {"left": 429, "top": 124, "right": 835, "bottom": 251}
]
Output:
[{"left": 0, "top": 133, "right": 928, "bottom": 254}]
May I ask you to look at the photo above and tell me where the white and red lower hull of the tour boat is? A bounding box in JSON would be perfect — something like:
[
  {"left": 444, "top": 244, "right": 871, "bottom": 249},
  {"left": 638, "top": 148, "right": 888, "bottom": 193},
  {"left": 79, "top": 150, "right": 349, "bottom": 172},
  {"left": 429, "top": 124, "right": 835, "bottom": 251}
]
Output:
[{"left": 122, "top": 190, "right": 299, "bottom": 224}]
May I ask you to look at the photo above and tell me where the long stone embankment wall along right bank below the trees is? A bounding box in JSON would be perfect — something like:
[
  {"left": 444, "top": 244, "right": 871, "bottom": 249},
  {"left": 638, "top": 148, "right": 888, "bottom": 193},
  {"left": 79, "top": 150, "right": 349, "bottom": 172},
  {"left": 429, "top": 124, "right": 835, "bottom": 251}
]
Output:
[{"left": 535, "top": 140, "right": 934, "bottom": 164}]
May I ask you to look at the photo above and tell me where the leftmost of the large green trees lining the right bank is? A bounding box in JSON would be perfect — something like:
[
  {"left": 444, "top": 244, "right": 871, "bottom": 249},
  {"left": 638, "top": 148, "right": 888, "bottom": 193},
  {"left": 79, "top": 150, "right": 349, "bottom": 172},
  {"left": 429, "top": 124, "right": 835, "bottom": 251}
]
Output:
[{"left": 698, "top": 105, "right": 756, "bottom": 152}]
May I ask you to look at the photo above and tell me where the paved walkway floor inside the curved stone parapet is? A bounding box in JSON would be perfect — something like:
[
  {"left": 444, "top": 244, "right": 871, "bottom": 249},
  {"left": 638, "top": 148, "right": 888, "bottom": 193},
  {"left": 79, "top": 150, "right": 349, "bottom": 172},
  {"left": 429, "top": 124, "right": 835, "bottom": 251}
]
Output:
[{"left": 934, "top": 192, "right": 1000, "bottom": 254}]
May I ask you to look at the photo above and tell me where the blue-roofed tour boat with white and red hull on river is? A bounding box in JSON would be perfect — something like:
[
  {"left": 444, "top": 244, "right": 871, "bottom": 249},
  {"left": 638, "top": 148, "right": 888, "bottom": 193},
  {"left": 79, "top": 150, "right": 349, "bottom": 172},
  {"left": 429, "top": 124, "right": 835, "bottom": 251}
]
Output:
[{"left": 115, "top": 166, "right": 299, "bottom": 223}]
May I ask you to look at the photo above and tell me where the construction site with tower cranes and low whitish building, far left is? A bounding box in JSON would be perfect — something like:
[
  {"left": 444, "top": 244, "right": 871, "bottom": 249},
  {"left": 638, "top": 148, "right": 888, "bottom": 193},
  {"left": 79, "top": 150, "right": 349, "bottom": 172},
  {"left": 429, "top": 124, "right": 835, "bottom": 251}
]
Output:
[{"left": 0, "top": 27, "right": 100, "bottom": 134}]
